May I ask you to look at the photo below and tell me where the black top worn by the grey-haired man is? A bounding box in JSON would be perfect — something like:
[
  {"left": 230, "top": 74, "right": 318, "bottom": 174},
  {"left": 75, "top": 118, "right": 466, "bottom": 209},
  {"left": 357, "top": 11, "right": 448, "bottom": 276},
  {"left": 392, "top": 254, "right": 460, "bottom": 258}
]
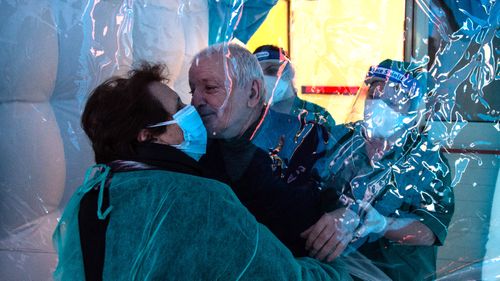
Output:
[{"left": 200, "top": 118, "right": 323, "bottom": 256}]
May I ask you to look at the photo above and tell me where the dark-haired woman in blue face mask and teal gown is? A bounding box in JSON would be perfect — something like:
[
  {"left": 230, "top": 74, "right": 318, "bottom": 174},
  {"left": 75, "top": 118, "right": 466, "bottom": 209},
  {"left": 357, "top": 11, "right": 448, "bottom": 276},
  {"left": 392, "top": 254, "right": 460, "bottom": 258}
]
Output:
[{"left": 53, "top": 64, "right": 349, "bottom": 280}]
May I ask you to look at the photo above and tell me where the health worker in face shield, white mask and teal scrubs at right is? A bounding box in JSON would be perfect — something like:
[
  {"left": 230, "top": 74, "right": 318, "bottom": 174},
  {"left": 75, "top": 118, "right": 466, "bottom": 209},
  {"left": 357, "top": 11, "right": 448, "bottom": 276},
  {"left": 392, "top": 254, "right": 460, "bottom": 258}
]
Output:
[{"left": 303, "top": 60, "right": 454, "bottom": 280}]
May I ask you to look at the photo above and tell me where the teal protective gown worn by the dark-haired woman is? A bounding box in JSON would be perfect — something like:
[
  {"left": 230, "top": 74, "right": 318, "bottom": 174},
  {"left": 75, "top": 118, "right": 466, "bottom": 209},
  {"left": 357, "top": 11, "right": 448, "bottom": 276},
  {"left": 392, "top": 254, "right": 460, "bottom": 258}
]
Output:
[{"left": 53, "top": 165, "right": 350, "bottom": 280}]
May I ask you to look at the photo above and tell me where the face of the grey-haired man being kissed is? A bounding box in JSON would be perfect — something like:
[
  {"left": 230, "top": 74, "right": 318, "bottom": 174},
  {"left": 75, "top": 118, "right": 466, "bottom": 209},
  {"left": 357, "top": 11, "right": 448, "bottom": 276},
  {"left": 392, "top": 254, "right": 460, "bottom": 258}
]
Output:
[{"left": 189, "top": 53, "right": 251, "bottom": 139}]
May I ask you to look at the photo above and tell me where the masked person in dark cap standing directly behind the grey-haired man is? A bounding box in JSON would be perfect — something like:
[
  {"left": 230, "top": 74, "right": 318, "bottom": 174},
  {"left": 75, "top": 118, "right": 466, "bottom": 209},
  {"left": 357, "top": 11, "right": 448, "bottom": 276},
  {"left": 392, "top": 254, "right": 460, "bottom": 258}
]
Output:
[{"left": 254, "top": 45, "right": 335, "bottom": 131}]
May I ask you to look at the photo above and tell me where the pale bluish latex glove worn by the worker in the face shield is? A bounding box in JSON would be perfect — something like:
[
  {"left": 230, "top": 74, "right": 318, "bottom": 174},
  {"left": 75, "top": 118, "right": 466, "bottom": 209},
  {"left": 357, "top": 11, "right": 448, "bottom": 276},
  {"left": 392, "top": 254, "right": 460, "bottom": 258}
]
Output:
[{"left": 355, "top": 201, "right": 388, "bottom": 237}]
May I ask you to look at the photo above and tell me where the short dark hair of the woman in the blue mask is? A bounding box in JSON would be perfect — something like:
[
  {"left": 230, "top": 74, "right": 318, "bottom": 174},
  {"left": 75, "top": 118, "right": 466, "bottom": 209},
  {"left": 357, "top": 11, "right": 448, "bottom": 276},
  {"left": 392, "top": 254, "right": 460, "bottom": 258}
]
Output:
[{"left": 82, "top": 62, "right": 172, "bottom": 163}]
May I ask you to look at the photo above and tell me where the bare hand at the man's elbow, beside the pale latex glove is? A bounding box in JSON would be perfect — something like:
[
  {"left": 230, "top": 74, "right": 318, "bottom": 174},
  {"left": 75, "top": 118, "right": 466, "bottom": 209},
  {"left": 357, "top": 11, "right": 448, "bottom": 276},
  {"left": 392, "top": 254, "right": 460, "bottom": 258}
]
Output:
[{"left": 300, "top": 208, "right": 359, "bottom": 262}]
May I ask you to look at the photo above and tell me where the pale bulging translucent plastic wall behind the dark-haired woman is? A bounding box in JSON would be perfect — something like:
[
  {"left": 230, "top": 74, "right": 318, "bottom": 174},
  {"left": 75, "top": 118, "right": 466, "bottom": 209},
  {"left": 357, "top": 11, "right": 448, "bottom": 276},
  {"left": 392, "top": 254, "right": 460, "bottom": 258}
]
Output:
[{"left": 0, "top": 0, "right": 208, "bottom": 280}]
